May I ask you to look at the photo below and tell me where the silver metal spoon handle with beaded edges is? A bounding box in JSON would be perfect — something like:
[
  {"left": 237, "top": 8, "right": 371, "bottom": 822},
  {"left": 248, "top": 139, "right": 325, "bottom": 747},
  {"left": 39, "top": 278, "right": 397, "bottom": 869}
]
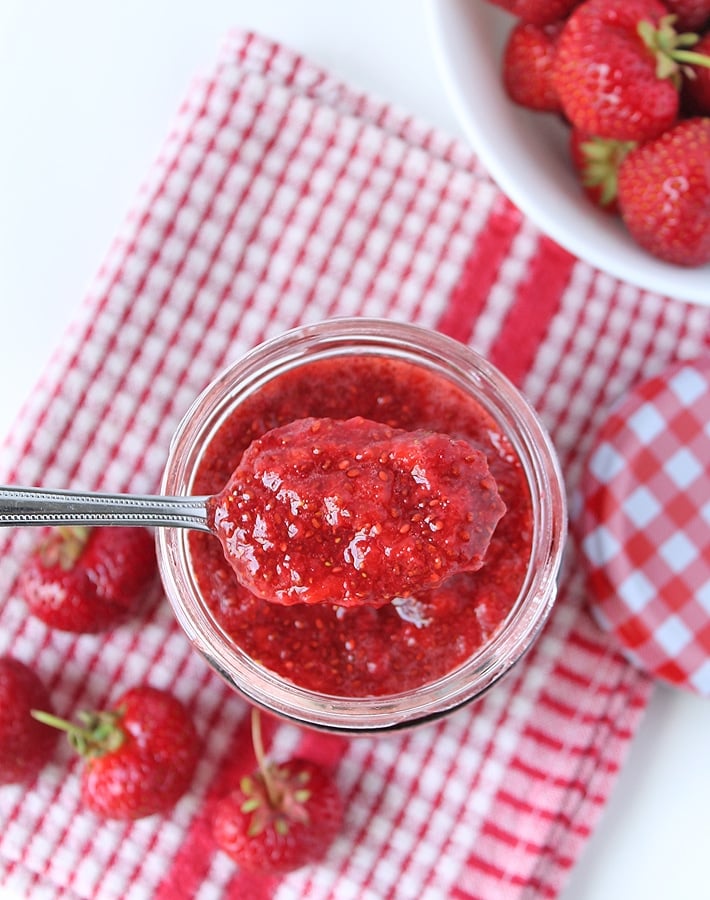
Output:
[{"left": 0, "top": 486, "right": 210, "bottom": 531}]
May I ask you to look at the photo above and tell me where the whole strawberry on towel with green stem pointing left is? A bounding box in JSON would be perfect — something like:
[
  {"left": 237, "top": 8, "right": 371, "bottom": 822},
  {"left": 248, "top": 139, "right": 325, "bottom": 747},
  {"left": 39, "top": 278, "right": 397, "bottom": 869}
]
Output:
[{"left": 34, "top": 685, "right": 201, "bottom": 819}]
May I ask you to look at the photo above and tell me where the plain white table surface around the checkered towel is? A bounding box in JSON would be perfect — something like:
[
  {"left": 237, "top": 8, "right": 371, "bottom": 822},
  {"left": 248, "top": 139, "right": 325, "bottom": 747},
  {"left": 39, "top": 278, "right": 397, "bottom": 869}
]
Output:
[{"left": 0, "top": 0, "right": 710, "bottom": 900}]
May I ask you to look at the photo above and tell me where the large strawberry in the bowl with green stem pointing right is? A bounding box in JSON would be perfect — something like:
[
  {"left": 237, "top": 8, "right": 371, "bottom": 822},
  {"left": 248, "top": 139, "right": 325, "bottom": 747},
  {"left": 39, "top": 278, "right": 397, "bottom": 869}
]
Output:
[{"left": 554, "top": 0, "right": 710, "bottom": 141}]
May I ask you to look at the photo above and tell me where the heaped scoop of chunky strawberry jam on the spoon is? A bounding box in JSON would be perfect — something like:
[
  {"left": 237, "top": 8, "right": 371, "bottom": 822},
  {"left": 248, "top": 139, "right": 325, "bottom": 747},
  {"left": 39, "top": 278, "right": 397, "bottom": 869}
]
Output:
[{"left": 209, "top": 416, "right": 505, "bottom": 607}]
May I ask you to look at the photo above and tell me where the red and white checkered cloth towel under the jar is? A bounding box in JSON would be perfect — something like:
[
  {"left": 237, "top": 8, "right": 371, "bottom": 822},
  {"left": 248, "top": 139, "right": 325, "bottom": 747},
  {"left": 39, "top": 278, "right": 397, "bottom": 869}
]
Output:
[{"left": 0, "top": 33, "right": 710, "bottom": 900}]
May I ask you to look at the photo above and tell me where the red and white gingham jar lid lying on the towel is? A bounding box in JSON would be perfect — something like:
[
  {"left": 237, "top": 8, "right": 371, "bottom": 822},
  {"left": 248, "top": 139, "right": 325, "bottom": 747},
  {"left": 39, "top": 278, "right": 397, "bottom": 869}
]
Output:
[{"left": 580, "top": 357, "right": 710, "bottom": 696}]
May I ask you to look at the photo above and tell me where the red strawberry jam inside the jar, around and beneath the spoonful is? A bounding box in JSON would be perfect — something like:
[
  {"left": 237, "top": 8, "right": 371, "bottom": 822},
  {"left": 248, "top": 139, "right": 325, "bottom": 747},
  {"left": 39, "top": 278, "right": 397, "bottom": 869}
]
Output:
[{"left": 189, "top": 355, "right": 532, "bottom": 697}]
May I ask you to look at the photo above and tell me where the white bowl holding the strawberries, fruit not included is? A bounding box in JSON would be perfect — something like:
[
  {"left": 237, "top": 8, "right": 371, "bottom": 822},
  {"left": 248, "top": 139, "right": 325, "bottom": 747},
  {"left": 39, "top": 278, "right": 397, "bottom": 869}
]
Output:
[{"left": 428, "top": 0, "right": 710, "bottom": 306}]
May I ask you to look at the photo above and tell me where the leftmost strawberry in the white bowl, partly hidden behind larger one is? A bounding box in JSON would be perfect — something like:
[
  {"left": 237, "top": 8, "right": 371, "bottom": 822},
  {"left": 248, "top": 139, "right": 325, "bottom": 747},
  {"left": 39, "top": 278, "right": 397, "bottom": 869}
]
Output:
[{"left": 503, "top": 22, "right": 562, "bottom": 112}]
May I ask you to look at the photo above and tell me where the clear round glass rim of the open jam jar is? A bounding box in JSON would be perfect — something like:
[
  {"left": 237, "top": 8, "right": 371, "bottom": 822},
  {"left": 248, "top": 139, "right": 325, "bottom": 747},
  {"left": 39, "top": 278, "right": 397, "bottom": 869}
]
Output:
[{"left": 158, "top": 318, "right": 567, "bottom": 734}]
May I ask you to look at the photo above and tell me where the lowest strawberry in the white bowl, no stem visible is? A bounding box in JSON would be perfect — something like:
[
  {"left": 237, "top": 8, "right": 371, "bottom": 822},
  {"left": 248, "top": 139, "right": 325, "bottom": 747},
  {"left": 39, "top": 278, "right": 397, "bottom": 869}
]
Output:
[{"left": 619, "top": 118, "right": 710, "bottom": 266}]
